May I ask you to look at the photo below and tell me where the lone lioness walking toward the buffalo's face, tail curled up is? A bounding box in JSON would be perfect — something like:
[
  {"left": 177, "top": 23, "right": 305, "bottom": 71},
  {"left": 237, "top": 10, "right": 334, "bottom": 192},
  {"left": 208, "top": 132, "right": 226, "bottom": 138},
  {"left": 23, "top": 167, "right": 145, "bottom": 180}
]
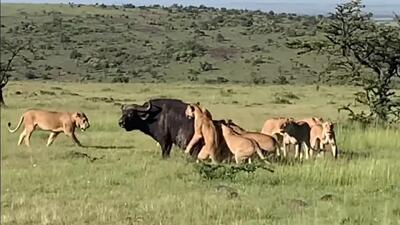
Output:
[{"left": 8, "top": 109, "right": 90, "bottom": 147}]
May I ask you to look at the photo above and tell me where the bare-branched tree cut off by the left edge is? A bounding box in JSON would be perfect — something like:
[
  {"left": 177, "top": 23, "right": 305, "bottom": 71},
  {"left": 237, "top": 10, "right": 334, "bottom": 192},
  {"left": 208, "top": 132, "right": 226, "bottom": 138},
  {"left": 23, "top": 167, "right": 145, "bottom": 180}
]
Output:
[{"left": 0, "top": 37, "right": 33, "bottom": 106}]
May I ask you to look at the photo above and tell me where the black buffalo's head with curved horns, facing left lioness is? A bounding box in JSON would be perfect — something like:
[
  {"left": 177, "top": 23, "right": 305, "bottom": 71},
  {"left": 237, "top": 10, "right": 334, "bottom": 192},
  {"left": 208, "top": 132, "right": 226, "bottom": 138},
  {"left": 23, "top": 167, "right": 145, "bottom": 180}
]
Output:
[{"left": 118, "top": 101, "right": 152, "bottom": 131}]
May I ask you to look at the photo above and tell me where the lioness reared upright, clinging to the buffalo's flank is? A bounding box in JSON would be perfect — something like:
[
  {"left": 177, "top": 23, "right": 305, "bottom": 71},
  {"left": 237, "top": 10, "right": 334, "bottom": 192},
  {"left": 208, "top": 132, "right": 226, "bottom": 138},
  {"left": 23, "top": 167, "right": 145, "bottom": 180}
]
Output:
[{"left": 185, "top": 104, "right": 218, "bottom": 163}]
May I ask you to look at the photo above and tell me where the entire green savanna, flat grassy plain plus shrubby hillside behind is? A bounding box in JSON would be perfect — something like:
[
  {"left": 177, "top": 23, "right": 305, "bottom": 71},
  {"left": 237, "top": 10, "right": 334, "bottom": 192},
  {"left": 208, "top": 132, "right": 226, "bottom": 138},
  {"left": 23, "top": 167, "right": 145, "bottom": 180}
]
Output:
[{"left": 1, "top": 3, "right": 400, "bottom": 225}]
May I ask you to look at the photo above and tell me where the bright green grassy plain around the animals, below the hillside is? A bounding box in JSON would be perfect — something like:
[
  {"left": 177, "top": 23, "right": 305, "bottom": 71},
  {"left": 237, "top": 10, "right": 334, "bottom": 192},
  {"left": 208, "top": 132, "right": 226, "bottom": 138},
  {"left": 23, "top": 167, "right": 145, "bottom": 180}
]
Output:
[{"left": 1, "top": 82, "right": 400, "bottom": 225}]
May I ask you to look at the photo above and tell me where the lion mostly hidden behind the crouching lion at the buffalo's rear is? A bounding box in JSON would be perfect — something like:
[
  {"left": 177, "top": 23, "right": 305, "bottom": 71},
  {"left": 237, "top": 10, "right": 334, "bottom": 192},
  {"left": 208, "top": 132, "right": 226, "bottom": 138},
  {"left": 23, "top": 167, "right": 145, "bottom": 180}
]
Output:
[{"left": 227, "top": 119, "right": 280, "bottom": 156}]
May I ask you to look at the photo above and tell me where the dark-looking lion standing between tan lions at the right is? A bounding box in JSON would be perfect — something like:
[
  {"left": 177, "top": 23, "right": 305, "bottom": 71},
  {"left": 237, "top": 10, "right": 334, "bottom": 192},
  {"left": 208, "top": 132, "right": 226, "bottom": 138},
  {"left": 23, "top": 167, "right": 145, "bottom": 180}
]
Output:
[{"left": 280, "top": 120, "right": 311, "bottom": 159}]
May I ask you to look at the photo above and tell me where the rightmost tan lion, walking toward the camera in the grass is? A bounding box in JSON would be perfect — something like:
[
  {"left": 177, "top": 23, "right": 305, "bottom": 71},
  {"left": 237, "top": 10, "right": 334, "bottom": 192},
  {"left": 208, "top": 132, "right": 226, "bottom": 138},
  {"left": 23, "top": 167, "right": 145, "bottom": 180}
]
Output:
[{"left": 310, "top": 121, "right": 337, "bottom": 158}]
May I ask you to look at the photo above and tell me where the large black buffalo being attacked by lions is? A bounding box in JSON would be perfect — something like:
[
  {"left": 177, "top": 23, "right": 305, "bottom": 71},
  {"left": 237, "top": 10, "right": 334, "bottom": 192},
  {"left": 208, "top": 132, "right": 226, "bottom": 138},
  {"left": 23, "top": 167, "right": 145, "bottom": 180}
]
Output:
[{"left": 119, "top": 99, "right": 229, "bottom": 160}]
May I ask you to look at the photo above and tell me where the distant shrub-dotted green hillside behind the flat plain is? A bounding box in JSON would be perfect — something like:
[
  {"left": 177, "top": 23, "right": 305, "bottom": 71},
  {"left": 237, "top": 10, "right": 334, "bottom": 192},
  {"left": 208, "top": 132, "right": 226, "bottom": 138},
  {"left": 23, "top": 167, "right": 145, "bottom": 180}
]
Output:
[{"left": 1, "top": 4, "right": 392, "bottom": 84}]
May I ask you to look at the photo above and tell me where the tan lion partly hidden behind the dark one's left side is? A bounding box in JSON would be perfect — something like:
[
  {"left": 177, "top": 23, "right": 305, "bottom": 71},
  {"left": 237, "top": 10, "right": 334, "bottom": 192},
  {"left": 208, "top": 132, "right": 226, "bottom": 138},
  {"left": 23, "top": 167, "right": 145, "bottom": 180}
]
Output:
[{"left": 261, "top": 117, "right": 294, "bottom": 157}]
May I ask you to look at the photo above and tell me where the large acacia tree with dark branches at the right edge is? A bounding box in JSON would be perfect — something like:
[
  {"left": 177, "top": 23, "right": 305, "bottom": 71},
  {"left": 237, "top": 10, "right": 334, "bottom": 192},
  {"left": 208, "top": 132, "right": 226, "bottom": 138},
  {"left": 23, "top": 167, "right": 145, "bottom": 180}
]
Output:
[{"left": 289, "top": 0, "right": 400, "bottom": 123}]
